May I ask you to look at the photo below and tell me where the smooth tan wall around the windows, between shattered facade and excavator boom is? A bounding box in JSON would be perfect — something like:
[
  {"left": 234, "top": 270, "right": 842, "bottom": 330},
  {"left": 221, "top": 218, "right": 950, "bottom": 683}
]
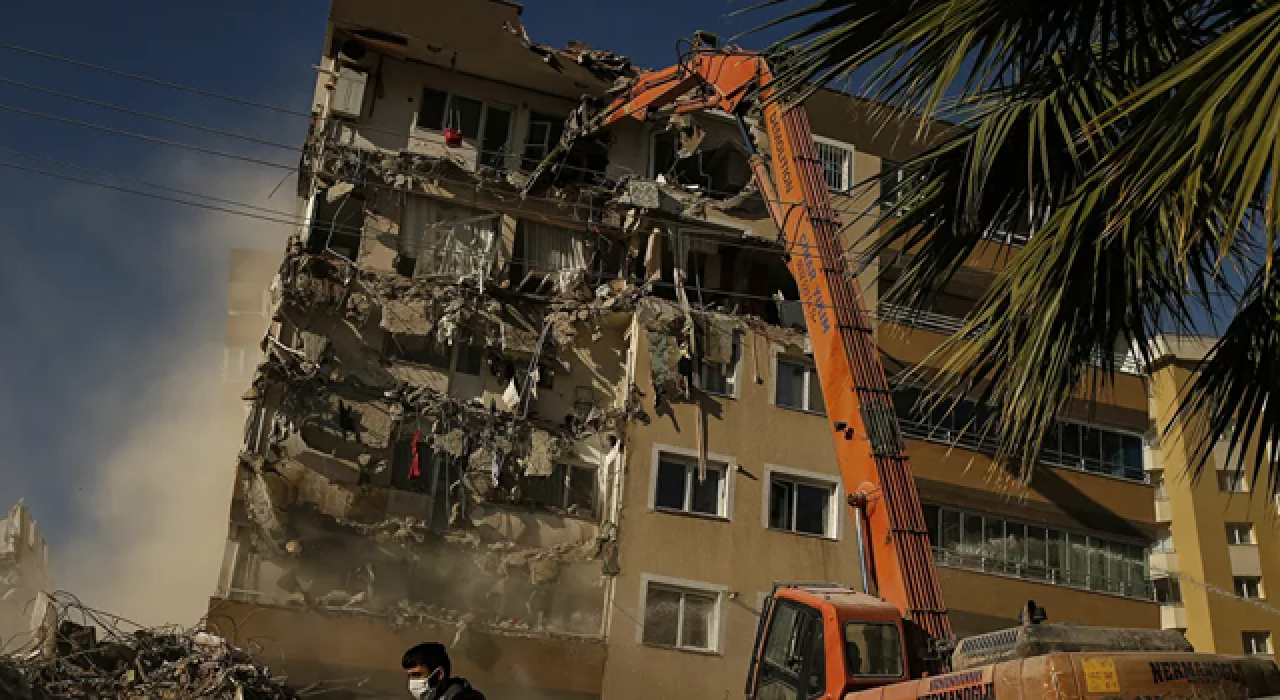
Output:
[{"left": 604, "top": 326, "right": 859, "bottom": 700}]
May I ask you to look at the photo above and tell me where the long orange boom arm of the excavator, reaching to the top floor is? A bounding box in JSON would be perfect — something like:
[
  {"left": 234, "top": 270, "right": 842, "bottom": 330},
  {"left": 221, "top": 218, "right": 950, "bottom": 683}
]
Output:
[{"left": 570, "top": 45, "right": 952, "bottom": 673}]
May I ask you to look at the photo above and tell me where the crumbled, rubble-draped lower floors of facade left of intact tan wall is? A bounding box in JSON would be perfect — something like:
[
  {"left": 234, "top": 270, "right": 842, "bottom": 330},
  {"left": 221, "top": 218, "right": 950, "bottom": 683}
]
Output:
[{"left": 222, "top": 230, "right": 650, "bottom": 635}]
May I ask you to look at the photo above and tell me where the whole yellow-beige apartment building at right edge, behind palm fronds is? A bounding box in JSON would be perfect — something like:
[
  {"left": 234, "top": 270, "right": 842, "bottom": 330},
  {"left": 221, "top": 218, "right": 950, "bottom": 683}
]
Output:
[{"left": 1151, "top": 335, "right": 1280, "bottom": 655}]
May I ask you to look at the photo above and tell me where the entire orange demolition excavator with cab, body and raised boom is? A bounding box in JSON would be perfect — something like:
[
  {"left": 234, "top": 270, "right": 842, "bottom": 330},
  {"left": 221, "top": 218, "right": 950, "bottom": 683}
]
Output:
[{"left": 530, "top": 35, "right": 1280, "bottom": 700}]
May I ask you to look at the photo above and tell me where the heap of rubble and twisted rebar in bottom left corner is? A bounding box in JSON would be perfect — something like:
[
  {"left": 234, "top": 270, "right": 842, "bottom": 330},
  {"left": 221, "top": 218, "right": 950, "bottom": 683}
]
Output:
[{"left": 0, "top": 600, "right": 298, "bottom": 700}]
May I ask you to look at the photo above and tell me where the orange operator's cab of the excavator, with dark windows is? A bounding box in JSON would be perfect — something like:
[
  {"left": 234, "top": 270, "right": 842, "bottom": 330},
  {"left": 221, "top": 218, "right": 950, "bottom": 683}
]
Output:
[{"left": 746, "top": 584, "right": 910, "bottom": 700}]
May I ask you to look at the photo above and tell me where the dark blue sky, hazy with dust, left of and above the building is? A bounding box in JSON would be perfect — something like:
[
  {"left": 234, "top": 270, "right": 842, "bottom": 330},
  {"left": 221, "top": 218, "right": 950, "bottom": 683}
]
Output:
[{"left": 0, "top": 0, "right": 798, "bottom": 622}]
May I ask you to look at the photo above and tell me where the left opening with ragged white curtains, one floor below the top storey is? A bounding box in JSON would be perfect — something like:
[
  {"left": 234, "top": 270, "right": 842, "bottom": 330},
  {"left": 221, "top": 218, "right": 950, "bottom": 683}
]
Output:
[{"left": 401, "top": 197, "right": 502, "bottom": 276}]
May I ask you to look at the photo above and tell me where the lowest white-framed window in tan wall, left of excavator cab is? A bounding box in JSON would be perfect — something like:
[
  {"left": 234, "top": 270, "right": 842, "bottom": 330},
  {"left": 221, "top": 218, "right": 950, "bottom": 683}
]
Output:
[{"left": 643, "top": 584, "right": 721, "bottom": 651}]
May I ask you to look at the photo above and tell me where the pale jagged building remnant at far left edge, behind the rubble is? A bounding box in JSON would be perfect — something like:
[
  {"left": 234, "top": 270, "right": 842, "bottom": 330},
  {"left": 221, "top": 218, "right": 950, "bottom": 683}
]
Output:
[{"left": 0, "top": 502, "right": 54, "bottom": 654}]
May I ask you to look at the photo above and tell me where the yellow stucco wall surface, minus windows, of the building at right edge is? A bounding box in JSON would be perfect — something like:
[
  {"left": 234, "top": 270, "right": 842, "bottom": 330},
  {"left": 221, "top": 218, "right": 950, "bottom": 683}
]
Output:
[{"left": 1152, "top": 361, "right": 1280, "bottom": 654}]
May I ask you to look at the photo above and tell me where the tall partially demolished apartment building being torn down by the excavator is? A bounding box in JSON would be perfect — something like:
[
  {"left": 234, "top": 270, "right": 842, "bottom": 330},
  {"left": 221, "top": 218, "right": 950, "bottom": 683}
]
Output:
[{"left": 210, "top": 0, "right": 1158, "bottom": 699}]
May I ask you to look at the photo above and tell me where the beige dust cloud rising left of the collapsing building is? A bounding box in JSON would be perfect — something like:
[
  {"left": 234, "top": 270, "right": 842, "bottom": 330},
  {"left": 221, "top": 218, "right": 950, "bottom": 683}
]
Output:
[{"left": 52, "top": 161, "right": 293, "bottom": 626}]
